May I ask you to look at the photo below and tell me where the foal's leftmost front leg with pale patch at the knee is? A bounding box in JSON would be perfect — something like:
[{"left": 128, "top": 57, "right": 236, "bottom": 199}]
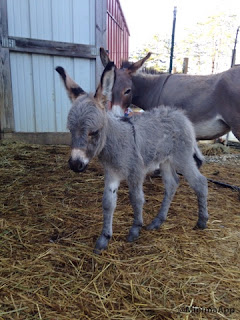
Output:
[{"left": 94, "top": 174, "right": 120, "bottom": 253}]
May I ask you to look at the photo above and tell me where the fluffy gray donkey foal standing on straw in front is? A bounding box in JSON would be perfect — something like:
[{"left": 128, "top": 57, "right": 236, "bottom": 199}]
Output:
[{"left": 56, "top": 63, "right": 208, "bottom": 253}]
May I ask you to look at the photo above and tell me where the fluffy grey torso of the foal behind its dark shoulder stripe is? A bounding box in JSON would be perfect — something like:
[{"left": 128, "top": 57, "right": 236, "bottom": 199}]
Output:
[{"left": 132, "top": 106, "right": 200, "bottom": 171}]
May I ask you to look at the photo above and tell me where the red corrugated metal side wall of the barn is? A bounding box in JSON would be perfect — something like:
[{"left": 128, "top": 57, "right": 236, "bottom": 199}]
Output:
[{"left": 107, "top": 0, "right": 130, "bottom": 67}]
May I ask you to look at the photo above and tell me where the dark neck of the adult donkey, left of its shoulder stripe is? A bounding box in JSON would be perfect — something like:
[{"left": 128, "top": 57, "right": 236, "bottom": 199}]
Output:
[{"left": 132, "top": 74, "right": 168, "bottom": 110}]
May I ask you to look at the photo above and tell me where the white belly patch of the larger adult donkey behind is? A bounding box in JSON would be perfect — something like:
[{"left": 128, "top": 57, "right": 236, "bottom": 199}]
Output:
[{"left": 193, "top": 115, "right": 230, "bottom": 140}]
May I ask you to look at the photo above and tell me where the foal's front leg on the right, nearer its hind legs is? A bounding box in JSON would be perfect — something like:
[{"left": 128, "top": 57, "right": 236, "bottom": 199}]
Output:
[{"left": 127, "top": 181, "right": 144, "bottom": 242}]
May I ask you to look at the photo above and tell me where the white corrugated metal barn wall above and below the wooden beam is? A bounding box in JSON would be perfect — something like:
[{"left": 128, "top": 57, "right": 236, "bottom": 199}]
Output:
[{"left": 7, "top": 0, "right": 95, "bottom": 132}]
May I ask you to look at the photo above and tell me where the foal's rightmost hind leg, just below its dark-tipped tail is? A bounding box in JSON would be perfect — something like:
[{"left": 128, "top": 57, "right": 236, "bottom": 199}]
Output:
[{"left": 181, "top": 161, "right": 208, "bottom": 229}]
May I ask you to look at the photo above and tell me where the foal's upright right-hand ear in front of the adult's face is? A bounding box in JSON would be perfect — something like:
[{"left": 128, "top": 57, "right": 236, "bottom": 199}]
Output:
[{"left": 94, "top": 62, "right": 116, "bottom": 104}]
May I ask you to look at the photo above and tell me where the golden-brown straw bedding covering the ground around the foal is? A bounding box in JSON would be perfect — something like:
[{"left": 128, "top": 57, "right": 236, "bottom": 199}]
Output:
[{"left": 0, "top": 141, "right": 240, "bottom": 320}]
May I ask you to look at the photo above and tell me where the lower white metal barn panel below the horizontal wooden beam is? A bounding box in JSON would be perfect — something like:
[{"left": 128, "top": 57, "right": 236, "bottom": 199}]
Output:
[{"left": 10, "top": 52, "right": 95, "bottom": 132}]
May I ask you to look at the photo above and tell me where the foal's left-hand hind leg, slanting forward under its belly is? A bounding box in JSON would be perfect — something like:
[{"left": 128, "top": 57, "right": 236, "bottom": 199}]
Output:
[{"left": 147, "top": 161, "right": 179, "bottom": 230}]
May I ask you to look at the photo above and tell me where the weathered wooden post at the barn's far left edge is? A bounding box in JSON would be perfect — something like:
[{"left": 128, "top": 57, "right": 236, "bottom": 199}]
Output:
[{"left": 0, "top": 0, "right": 14, "bottom": 138}]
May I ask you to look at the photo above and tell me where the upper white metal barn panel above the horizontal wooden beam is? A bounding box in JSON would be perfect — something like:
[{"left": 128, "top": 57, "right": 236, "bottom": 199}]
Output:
[{"left": 7, "top": 0, "right": 95, "bottom": 44}]
